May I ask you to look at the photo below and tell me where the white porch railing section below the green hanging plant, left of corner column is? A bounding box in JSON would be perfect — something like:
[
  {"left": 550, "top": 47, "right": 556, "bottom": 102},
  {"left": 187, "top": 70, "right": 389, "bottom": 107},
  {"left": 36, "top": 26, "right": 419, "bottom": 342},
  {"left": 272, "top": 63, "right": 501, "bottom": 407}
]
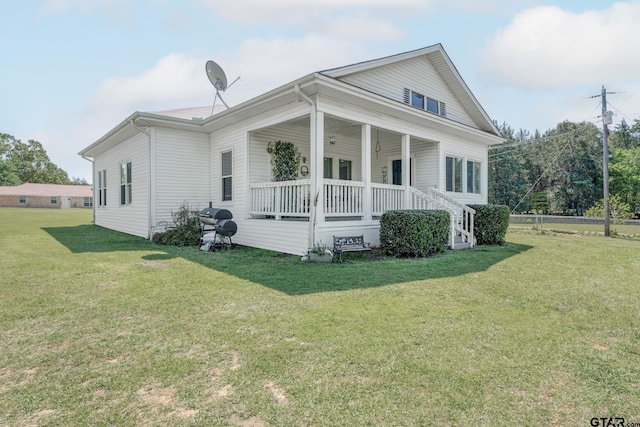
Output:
[{"left": 249, "top": 179, "right": 312, "bottom": 219}]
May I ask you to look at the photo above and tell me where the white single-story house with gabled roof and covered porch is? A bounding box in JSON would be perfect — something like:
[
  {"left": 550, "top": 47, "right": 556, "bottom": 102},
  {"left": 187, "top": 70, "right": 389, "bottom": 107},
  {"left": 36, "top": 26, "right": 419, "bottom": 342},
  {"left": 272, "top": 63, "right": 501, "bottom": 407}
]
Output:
[{"left": 79, "top": 44, "right": 502, "bottom": 254}]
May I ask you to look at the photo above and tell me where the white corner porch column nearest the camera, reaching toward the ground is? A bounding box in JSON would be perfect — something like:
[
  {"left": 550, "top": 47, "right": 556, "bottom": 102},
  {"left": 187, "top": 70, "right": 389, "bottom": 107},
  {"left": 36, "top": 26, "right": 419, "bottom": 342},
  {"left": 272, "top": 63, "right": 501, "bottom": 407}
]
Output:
[{"left": 309, "top": 108, "right": 324, "bottom": 248}]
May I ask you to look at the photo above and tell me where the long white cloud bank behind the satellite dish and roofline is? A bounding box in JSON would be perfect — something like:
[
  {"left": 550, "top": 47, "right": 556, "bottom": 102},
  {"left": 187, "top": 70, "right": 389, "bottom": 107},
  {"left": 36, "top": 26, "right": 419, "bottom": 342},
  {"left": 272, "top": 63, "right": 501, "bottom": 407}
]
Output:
[{"left": 60, "top": 35, "right": 371, "bottom": 179}]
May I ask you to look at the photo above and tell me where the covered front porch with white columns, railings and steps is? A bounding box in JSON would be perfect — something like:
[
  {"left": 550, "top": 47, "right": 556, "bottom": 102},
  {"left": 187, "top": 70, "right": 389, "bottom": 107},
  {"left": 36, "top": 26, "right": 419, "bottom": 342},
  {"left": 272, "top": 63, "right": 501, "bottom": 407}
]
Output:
[{"left": 246, "top": 109, "right": 474, "bottom": 251}]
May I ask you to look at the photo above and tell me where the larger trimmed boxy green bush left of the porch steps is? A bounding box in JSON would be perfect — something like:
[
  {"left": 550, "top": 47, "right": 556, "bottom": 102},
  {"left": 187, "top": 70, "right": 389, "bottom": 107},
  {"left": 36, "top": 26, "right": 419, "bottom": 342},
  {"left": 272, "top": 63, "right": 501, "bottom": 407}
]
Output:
[{"left": 380, "top": 210, "right": 451, "bottom": 257}]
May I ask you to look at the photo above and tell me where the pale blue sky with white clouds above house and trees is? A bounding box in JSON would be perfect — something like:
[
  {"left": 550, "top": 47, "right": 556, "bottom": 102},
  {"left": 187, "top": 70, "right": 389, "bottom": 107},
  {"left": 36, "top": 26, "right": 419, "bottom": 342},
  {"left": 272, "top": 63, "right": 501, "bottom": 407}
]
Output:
[{"left": 0, "top": 0, "right": 640, "bottom": 181}]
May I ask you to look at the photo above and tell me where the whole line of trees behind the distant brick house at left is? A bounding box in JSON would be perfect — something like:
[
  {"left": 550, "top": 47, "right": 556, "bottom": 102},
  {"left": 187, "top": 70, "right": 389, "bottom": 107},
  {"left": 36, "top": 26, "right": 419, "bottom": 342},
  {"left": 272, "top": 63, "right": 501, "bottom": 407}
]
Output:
[{"left": 0, "top": 133, "right": 87, "bottom": 186}]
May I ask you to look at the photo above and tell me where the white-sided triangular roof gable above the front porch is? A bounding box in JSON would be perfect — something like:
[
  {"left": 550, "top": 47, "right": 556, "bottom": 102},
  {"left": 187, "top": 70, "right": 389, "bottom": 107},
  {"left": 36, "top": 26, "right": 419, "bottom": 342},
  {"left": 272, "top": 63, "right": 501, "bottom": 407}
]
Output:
[{"left": 320, "top": 44, "right": 500, "bottom": 135}]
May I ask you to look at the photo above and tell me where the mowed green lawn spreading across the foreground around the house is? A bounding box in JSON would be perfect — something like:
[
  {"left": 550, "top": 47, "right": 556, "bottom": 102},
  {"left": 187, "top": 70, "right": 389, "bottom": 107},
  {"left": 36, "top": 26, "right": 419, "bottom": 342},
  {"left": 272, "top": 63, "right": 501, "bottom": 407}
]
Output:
[{"left": 0, "top": 208, "right": 640, "bottom": 426}]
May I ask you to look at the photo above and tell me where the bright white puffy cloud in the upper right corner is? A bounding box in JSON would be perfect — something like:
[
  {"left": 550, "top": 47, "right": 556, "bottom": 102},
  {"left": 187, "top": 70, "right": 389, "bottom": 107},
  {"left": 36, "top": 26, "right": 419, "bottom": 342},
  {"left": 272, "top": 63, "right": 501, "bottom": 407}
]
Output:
[{"left": 481, "top": 1, "right": 640, "bottom": 89}]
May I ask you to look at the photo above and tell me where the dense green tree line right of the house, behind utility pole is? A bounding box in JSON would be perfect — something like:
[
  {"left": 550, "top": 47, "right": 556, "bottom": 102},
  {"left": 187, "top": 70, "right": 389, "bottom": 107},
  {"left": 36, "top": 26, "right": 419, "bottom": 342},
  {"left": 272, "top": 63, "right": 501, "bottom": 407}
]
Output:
[{"left": 489, "top": 119, "right": 640, "bottom": 215}]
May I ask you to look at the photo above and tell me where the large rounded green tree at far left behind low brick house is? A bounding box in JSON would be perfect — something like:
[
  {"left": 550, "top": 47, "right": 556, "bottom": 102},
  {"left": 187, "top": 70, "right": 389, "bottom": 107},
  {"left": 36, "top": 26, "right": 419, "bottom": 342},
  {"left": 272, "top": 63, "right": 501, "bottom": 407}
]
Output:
[{"left": 0, "top": 133, "right": 71, "bottom": 184}]
